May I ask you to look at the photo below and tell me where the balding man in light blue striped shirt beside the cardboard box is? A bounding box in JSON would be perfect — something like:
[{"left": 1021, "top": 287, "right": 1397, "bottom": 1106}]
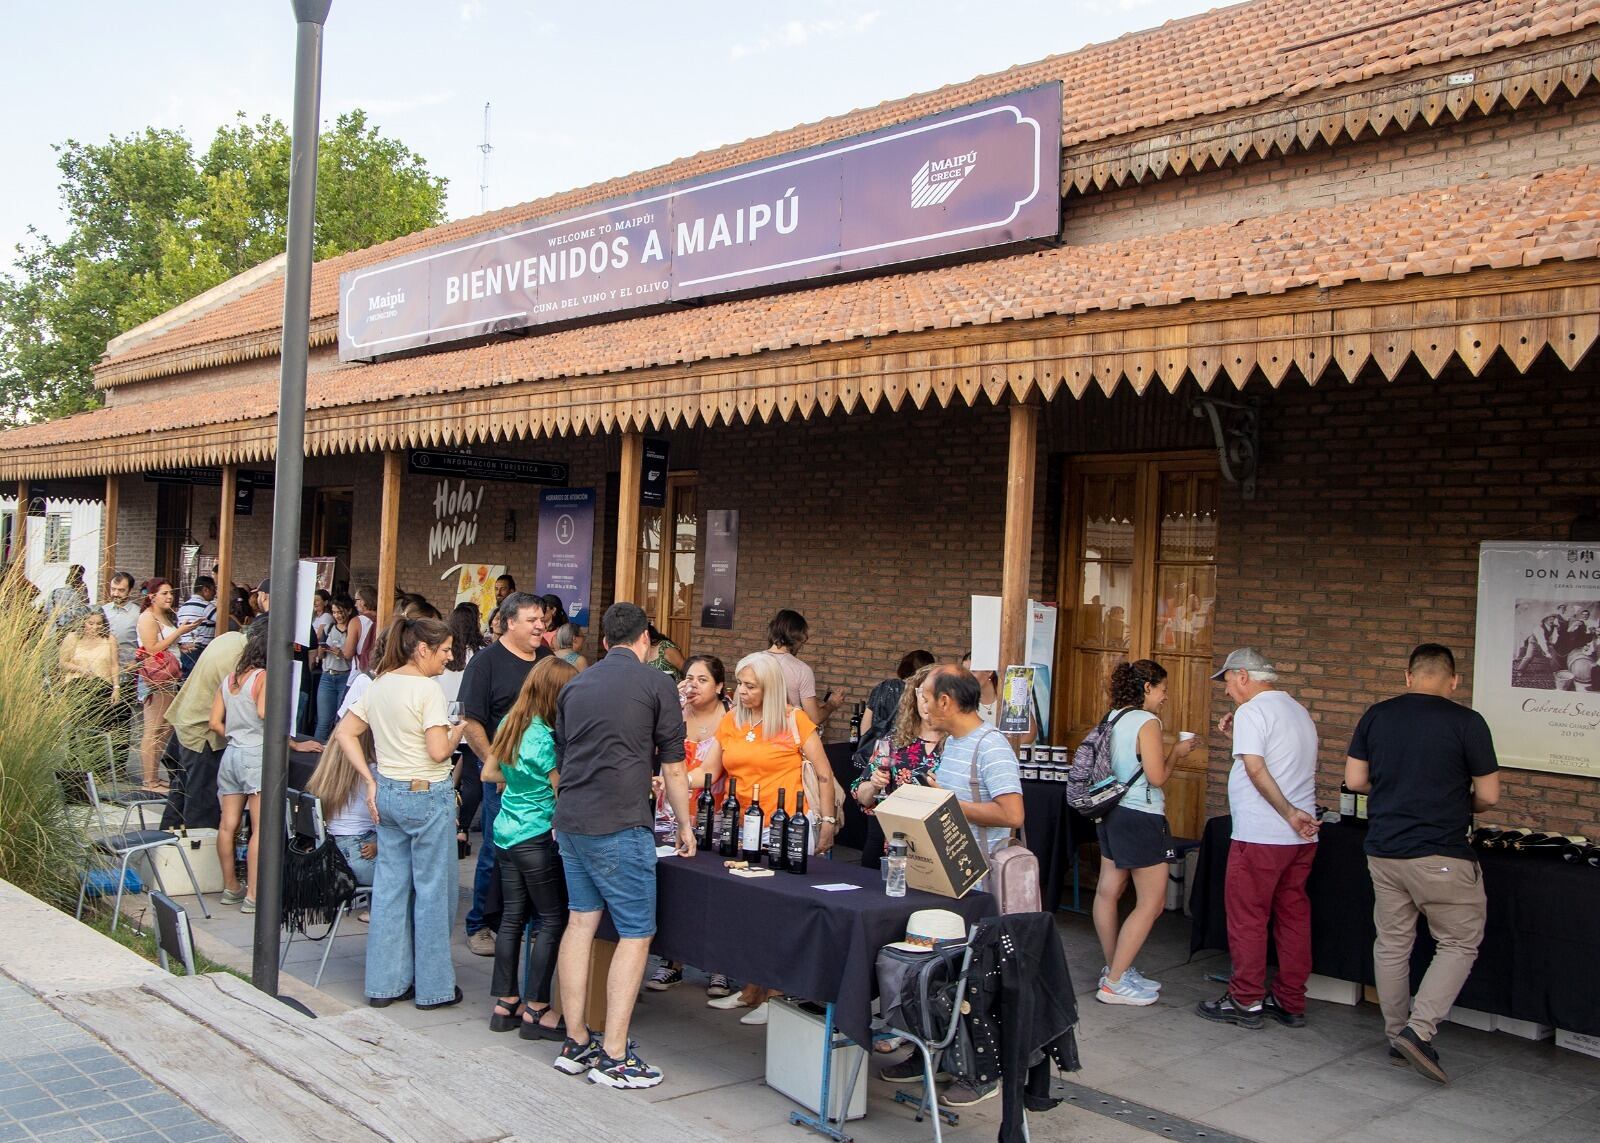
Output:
[{"left": 918, "top": 668, "right": 1022, "bottom": 853}]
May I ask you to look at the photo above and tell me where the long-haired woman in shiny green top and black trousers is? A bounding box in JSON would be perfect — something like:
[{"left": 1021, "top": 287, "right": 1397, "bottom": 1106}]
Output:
[{"left": 483, "top": 658, "right": 578, "bottom": 1042}]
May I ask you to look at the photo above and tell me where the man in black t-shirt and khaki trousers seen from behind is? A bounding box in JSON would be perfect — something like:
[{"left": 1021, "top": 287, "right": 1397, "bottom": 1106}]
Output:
[{"left": 1344, "top": 644, "right": 1499, "bottom": 1084}]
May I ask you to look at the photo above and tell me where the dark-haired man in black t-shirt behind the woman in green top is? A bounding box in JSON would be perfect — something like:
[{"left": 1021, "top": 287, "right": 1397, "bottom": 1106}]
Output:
[{"left": 461, "top": 591, "right": 552, "bottom": 956}]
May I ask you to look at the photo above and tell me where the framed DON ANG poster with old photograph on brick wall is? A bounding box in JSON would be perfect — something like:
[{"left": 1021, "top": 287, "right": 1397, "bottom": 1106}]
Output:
[{"left": 1472, "top": 541, "right": 1600, "bottom": 778}]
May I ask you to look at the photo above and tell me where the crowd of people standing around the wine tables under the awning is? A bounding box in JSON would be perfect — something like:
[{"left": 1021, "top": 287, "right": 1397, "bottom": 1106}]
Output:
[{"left": 34, "top": 568, "right": 1499, "bottom": 1105}]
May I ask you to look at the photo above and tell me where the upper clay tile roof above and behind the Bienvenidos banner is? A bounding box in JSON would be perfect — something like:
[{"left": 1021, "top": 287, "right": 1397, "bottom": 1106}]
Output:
[{"left": 101, "top": 0, "right": 1600, "bottom": 376}]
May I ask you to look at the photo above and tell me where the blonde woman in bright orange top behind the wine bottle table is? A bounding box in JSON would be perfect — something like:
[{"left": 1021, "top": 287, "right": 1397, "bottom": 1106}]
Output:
[{"left": 699, "top": 652, "right": 838, "bottom": 1025}]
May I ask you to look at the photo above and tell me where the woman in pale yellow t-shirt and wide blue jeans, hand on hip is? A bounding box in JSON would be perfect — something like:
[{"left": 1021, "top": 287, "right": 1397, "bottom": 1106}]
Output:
[{"left": 334, "top": 618, "right": 464, "bottom": 1009}]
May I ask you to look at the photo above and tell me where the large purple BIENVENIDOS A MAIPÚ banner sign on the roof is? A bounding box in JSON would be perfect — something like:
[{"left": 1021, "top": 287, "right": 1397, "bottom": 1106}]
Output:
[{"left": 339, "top": 83, "right": 1061, "bottom": 360}]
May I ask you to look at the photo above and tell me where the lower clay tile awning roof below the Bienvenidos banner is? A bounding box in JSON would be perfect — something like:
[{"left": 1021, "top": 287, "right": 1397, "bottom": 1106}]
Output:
[{"left": 0, "top": 166, "right": 1600, "bottom": 451}]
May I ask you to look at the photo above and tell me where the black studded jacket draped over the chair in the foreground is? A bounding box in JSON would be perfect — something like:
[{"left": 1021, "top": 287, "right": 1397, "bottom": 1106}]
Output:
[{"left": 944, "top": 912, "right": 1078, "bottom": 1143}]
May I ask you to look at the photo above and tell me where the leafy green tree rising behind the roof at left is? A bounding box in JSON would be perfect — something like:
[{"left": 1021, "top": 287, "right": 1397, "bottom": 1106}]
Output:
[{"left": 0, "top": 110, "right": 445, "bottom": 424}]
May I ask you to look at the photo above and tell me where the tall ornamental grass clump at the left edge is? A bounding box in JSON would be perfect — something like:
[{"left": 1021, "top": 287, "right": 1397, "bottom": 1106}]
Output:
[{"left": 0, "top": 575, "right": 106, "bottom": 909}]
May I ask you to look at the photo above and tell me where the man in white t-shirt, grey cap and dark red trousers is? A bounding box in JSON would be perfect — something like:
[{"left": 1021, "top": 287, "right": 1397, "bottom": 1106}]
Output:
[{"left": 1198, "top": 647, "right": 1317, "bottom": 1028}]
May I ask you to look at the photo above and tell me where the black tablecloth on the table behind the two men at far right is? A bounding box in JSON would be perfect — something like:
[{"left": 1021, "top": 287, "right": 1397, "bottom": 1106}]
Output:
[{"left": 1190, "top": 816, "right": 1600, "bottom": 1036}]
